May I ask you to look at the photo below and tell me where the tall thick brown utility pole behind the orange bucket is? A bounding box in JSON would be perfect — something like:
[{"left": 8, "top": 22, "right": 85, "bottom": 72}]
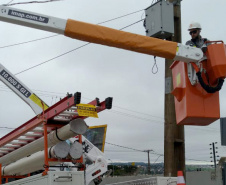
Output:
[{"left": 164, "top": 0, "right": 185, "bottom": 176}]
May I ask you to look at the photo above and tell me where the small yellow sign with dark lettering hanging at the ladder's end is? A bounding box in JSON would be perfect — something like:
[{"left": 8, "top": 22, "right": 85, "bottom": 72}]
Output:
[{"left": 76, "top": 104, "right": 98, "bottom": 118}]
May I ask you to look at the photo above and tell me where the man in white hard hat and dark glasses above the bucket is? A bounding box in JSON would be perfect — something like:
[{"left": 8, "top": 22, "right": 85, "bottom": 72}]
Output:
[{"left": 186, "top": 22, "right": 207, "bottom": 48}]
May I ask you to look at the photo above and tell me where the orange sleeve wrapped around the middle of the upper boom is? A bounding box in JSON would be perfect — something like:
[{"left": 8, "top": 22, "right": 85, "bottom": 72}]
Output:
[{"left": 64, "top": 19, "right": 177, "bottom": 59}]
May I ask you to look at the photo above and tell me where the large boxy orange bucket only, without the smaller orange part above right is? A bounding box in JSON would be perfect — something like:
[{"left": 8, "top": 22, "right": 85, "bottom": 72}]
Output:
[{"left": 170, "top": 61, "right": 220, "bottom": 126}]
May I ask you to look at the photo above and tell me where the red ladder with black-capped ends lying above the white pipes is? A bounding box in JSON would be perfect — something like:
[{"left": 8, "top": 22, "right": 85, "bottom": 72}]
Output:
[{"left": 0, "top": 92, "right": 112, "bottom": 163}]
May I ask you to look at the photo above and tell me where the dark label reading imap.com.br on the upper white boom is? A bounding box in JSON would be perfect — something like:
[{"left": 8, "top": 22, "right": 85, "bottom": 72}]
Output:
[{"left": 8, "top": 9, "right": 49, "bottom": 23}]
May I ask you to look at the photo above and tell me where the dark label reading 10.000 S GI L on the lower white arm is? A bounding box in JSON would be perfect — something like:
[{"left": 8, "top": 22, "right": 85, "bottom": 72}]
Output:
[{"left": 0, "top": 69, "right": 31, "bottom": 98}]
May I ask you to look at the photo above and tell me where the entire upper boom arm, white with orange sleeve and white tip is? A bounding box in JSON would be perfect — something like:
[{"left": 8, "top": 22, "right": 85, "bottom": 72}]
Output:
[{"left": 0, "top": 6, "right": 203, "bottom": 62}]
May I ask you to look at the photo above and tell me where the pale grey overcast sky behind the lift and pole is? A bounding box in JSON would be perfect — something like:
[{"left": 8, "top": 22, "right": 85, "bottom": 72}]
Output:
[{"left": 0, "top": 0, "right": 226, "bottom": 163}]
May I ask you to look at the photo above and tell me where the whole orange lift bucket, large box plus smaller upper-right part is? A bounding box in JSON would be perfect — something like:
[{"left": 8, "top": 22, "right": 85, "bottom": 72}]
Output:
[{"left": 170, "top": 41, "right": 226, "bottom": 126}]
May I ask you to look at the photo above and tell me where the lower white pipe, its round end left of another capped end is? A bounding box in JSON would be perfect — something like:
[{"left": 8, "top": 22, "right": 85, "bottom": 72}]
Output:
[{"left": 2, "top": 141, "right": 70, "bottom": 176}]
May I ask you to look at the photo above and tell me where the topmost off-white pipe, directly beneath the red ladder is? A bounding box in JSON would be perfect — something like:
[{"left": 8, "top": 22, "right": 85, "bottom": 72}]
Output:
[{"left": 0, "top": 119, "right": 88, "bottom": 165}]
